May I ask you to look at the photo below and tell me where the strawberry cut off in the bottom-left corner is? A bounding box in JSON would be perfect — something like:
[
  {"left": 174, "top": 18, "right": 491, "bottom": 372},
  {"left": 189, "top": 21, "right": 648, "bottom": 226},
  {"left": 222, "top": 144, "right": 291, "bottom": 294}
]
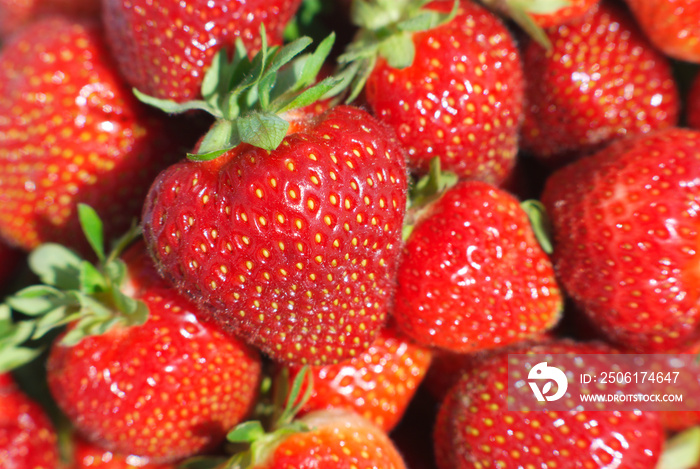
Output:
[{"left": 0, "top": 373, "right": 59, "bottom": 469}]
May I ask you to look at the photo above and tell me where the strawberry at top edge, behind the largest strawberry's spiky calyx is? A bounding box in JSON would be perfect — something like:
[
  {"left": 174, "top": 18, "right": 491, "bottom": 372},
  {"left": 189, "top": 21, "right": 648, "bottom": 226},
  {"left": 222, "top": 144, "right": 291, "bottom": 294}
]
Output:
[{"left": 103, "top": 0, "right": 301, "bottom": 102}]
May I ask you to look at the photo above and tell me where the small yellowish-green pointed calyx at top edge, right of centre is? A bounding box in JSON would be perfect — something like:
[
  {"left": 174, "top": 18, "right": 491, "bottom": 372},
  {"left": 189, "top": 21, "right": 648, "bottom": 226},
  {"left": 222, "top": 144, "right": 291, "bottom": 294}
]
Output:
[{"left": 482, "top": 0, "right": 571, "bottom": 50}]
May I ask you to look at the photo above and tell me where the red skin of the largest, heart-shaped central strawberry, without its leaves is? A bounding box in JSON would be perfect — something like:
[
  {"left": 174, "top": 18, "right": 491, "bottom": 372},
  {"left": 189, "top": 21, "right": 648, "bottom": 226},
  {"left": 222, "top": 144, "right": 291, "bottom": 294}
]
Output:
[{"left": 143, "top": 106, "right": 406, "bottom": 365}]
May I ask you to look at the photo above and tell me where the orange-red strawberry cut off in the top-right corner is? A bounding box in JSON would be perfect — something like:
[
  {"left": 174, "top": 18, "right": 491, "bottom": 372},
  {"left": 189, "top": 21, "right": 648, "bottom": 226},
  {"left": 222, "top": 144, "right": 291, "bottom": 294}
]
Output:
[{"left": 625, "top": 0, "right": 700, "bottom": 63}]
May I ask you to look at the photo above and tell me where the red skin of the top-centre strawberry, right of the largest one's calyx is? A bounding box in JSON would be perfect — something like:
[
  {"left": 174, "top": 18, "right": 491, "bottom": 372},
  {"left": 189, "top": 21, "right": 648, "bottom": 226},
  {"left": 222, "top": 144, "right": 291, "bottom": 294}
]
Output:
[{"left": 365, "top": 1, "right": 523, "bottom": 184}]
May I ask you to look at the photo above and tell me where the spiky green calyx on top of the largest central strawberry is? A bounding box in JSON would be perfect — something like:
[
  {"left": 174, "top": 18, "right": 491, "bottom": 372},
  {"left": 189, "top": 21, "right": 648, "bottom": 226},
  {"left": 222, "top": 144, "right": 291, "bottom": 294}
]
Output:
[{"left": 134, "top": 27, "right": 343, "bottom": 161}]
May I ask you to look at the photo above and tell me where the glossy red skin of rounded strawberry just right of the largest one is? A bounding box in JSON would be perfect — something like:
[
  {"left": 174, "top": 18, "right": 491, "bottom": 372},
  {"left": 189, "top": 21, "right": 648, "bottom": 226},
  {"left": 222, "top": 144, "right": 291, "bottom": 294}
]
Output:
[{"left": 394, "top": 181, "right": 562, "bottom": 353}]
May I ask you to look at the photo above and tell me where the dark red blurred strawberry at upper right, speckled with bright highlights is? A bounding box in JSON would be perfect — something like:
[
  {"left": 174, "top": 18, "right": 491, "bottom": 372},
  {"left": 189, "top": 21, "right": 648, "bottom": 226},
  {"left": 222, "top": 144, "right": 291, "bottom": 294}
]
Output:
[{"left": 521, "top": 3, "right": 679, "bottom": 166}]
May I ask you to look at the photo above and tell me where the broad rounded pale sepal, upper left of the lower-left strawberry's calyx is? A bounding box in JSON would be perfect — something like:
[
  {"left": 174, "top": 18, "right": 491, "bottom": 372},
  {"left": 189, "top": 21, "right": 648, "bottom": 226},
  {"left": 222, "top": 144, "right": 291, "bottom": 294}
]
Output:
[{"left": 27, "top": 243, "right": 83, "bottom": 290}]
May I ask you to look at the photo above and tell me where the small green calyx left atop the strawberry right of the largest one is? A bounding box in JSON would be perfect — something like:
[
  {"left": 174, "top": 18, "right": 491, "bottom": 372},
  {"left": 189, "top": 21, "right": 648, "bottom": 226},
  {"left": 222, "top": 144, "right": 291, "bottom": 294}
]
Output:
[{"left": 403, "top": 157, "right": 459, "bottom": 241}]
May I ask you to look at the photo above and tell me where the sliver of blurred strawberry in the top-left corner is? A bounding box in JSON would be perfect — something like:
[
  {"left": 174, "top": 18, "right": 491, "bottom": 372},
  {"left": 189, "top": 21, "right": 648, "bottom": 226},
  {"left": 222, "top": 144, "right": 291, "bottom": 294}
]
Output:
[{"left": 0, "top": 0, "right": 101, "bottom": 39}]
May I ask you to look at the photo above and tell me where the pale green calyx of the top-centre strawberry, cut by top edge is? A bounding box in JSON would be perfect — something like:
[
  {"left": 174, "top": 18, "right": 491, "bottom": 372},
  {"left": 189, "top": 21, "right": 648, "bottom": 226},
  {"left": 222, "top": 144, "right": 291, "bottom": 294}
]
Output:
[{"left": 338, "top": 0, "right": 459, "bottom": 102}]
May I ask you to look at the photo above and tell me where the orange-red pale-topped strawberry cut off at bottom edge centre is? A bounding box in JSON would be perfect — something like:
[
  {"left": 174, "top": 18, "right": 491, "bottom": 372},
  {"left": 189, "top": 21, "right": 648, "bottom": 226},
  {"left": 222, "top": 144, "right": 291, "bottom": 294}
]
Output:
[{"left": 248, "top": 409, "right": 406, "bottom": 469}]
